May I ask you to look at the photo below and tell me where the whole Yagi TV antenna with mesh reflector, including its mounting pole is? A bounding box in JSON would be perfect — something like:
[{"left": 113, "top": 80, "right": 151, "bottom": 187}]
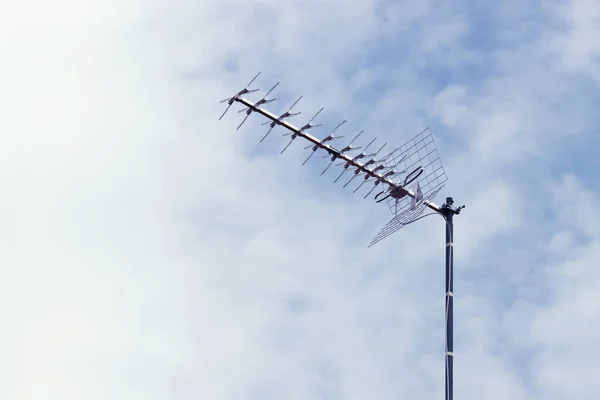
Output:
[{"left": 219, "top": 72, "right": 464, "bottom": 400}]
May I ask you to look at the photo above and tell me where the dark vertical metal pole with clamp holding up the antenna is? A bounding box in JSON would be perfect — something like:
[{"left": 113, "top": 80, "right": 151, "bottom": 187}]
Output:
[{"left": 441, "top": 197, "right": 460, "bottom": 400}]
